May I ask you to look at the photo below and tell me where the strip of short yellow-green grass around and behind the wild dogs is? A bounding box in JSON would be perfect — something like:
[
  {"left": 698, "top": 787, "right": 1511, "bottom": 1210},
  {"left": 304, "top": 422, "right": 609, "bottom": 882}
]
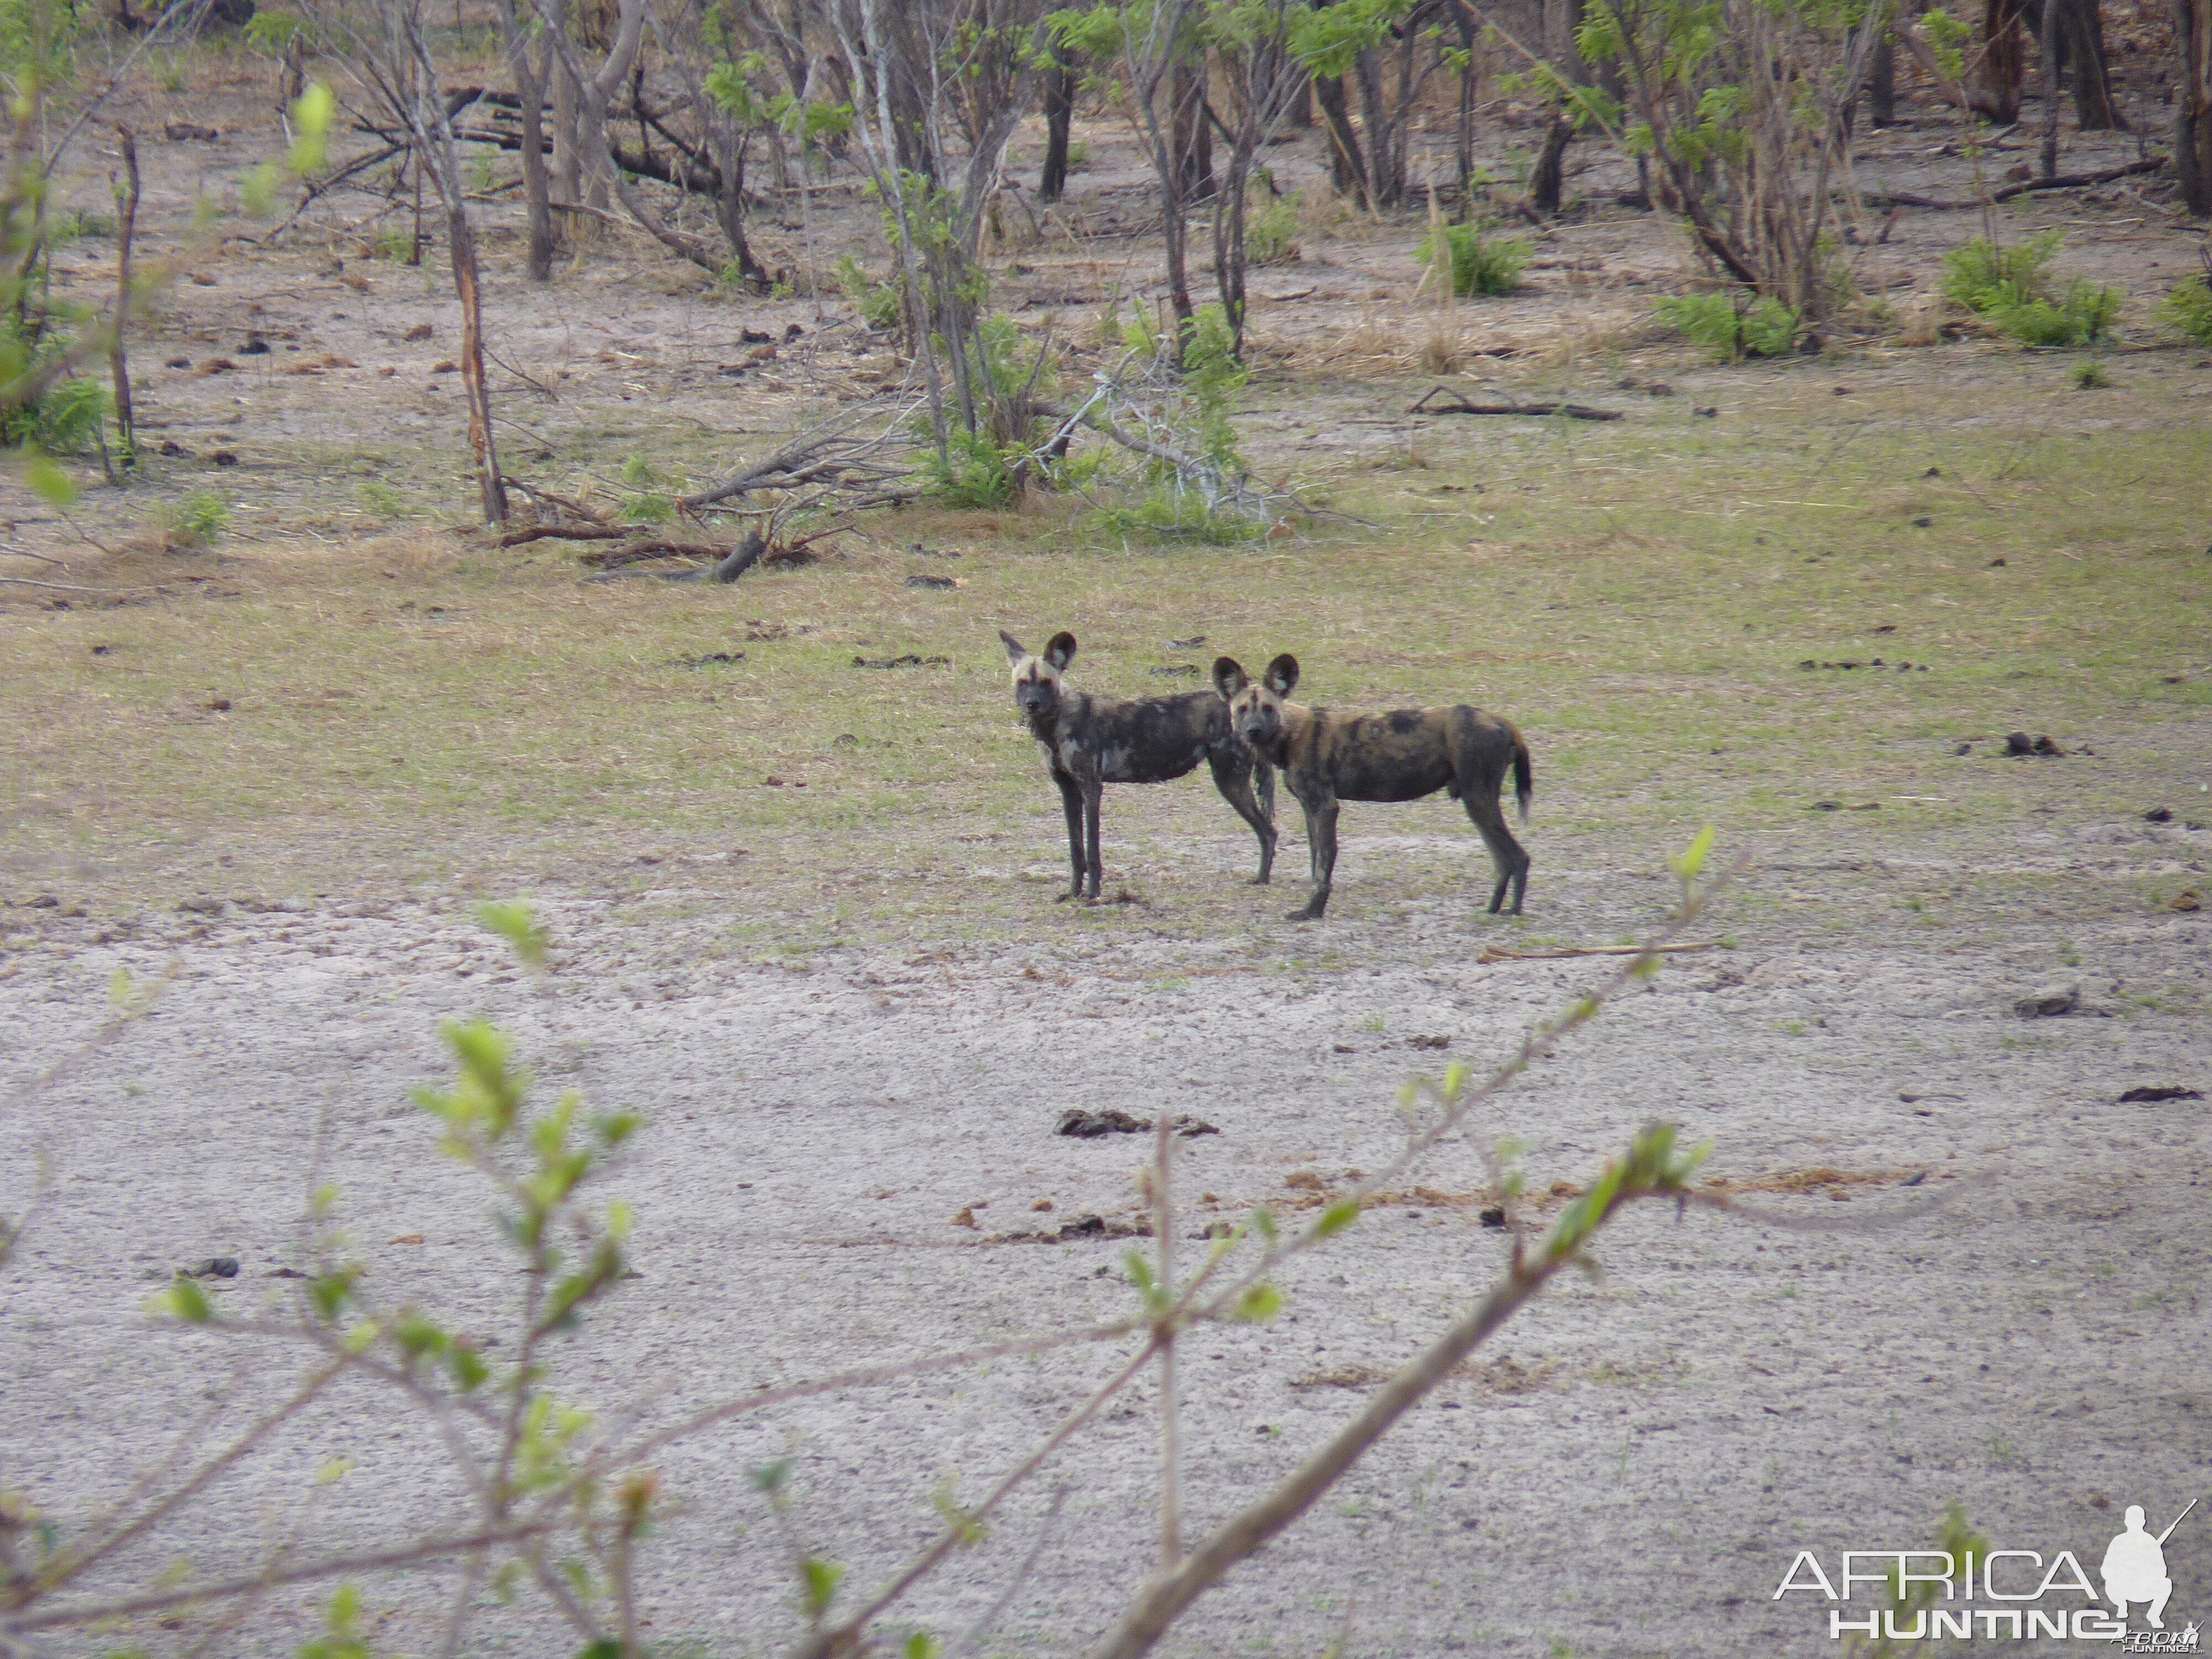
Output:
[{"left": 0, "top": 361, "right": 2212, "bottom": 956}]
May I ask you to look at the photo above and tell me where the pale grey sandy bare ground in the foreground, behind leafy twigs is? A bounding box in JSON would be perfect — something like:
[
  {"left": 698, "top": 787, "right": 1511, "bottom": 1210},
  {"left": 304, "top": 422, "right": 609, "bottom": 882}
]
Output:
[{"left": 0, "top": 787, "right": 2212, "bottom": 1655}]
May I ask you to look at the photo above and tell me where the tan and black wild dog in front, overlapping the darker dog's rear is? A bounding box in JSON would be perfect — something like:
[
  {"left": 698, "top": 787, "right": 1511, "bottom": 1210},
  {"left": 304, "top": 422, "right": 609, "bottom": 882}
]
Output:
[{"left": 1214, "top": 653, "right": 1531, "bottom": 922}]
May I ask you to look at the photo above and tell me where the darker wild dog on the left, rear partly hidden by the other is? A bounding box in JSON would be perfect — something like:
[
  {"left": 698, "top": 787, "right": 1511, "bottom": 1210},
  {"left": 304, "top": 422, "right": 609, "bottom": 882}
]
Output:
[{"left": 998, "top": 630, "right": 1274, "bottom": 898}]
